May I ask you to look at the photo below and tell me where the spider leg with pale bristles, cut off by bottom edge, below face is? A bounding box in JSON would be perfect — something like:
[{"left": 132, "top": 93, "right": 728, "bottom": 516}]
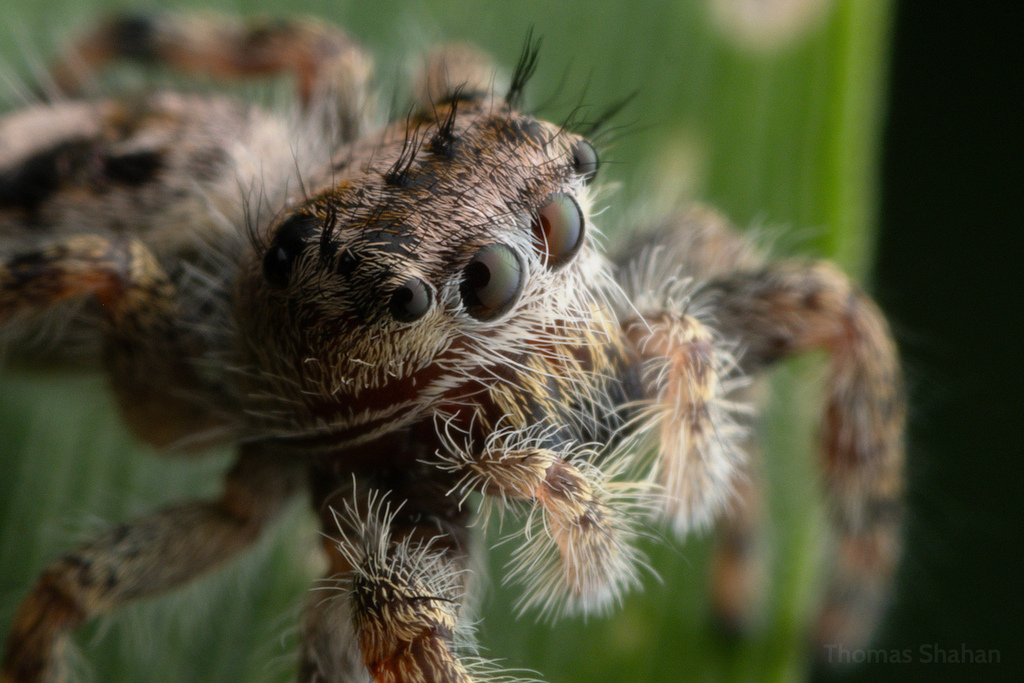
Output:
[{"left": 300, "top": 473, "right": 480, "bottom": 683}]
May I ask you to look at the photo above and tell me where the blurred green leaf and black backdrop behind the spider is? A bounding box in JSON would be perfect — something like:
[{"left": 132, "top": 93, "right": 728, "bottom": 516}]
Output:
[{"left": 0, "top": 0, "right": 1024, "bottom": 683}]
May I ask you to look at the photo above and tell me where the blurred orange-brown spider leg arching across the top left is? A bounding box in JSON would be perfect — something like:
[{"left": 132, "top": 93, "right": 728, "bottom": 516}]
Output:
[{"left": 52, "top": 13, "right": 373, "bottom": 142}]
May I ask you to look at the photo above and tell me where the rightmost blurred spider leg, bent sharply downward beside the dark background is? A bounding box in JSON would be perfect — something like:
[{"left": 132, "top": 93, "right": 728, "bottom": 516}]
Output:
[{"left": 707, "top": 263, "right": 905, "bottom": 646}]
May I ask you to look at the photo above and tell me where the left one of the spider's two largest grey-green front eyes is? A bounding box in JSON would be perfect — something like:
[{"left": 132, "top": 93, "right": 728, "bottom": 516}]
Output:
[{"left": 460, "top": 244, "right": 524, "bottom": 321}]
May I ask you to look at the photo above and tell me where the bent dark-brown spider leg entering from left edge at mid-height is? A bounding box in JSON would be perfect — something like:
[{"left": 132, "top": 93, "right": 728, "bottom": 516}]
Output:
[{"left": 0, "top": 236, "right": 221, "bottom": 446}]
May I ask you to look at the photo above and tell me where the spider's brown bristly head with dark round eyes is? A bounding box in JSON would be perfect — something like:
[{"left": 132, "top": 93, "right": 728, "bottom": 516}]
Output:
[{"left": 237, "top": 96, "right": 599, "bottom": 444}]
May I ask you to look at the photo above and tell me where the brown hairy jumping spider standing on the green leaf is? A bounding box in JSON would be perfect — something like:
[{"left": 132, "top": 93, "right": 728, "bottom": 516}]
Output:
[{"left": 0, "top": 15, "right": 904, "bottom": 683}]
